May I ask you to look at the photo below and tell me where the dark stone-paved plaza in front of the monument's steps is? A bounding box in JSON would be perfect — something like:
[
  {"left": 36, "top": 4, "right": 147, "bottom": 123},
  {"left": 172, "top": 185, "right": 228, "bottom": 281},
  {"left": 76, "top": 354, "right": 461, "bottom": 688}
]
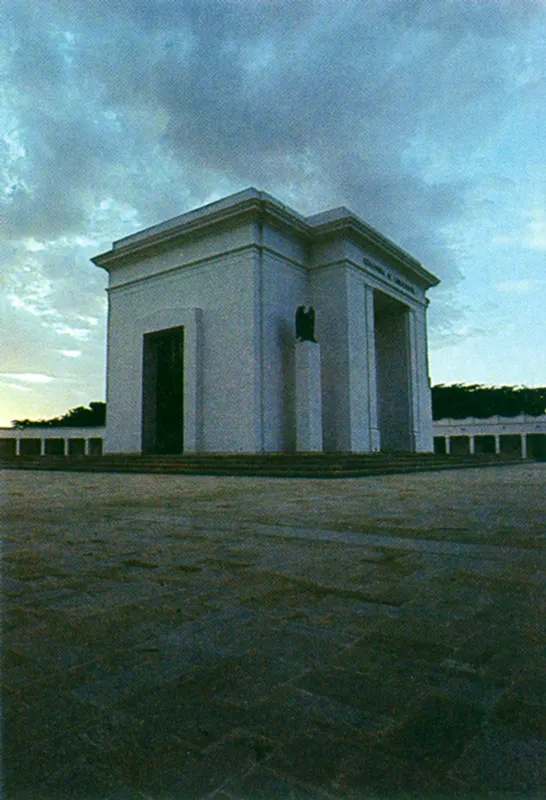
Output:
[{"left": 0, "top": 463, "right": 546, "bottom": 800}]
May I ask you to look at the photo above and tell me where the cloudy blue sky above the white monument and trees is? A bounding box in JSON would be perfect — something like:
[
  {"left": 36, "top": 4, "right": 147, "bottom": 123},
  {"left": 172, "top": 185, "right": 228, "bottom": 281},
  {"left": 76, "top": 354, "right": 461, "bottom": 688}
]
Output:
[{"left": 0, "top": 0, "right": 546, "bottom": 425}]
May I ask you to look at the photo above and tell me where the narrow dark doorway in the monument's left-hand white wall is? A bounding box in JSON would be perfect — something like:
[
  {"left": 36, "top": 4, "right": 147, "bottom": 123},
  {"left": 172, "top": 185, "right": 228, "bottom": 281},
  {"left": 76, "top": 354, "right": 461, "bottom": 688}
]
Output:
[{"left": 142, "top": 327, "right": 184, "bottom": 454}]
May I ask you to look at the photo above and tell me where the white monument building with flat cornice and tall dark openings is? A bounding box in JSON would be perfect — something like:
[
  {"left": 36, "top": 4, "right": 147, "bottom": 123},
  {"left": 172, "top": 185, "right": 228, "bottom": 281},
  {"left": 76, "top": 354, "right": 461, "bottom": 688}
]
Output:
[{"left": 93, "top": 184, "right": 438, "bottom": 454}]
